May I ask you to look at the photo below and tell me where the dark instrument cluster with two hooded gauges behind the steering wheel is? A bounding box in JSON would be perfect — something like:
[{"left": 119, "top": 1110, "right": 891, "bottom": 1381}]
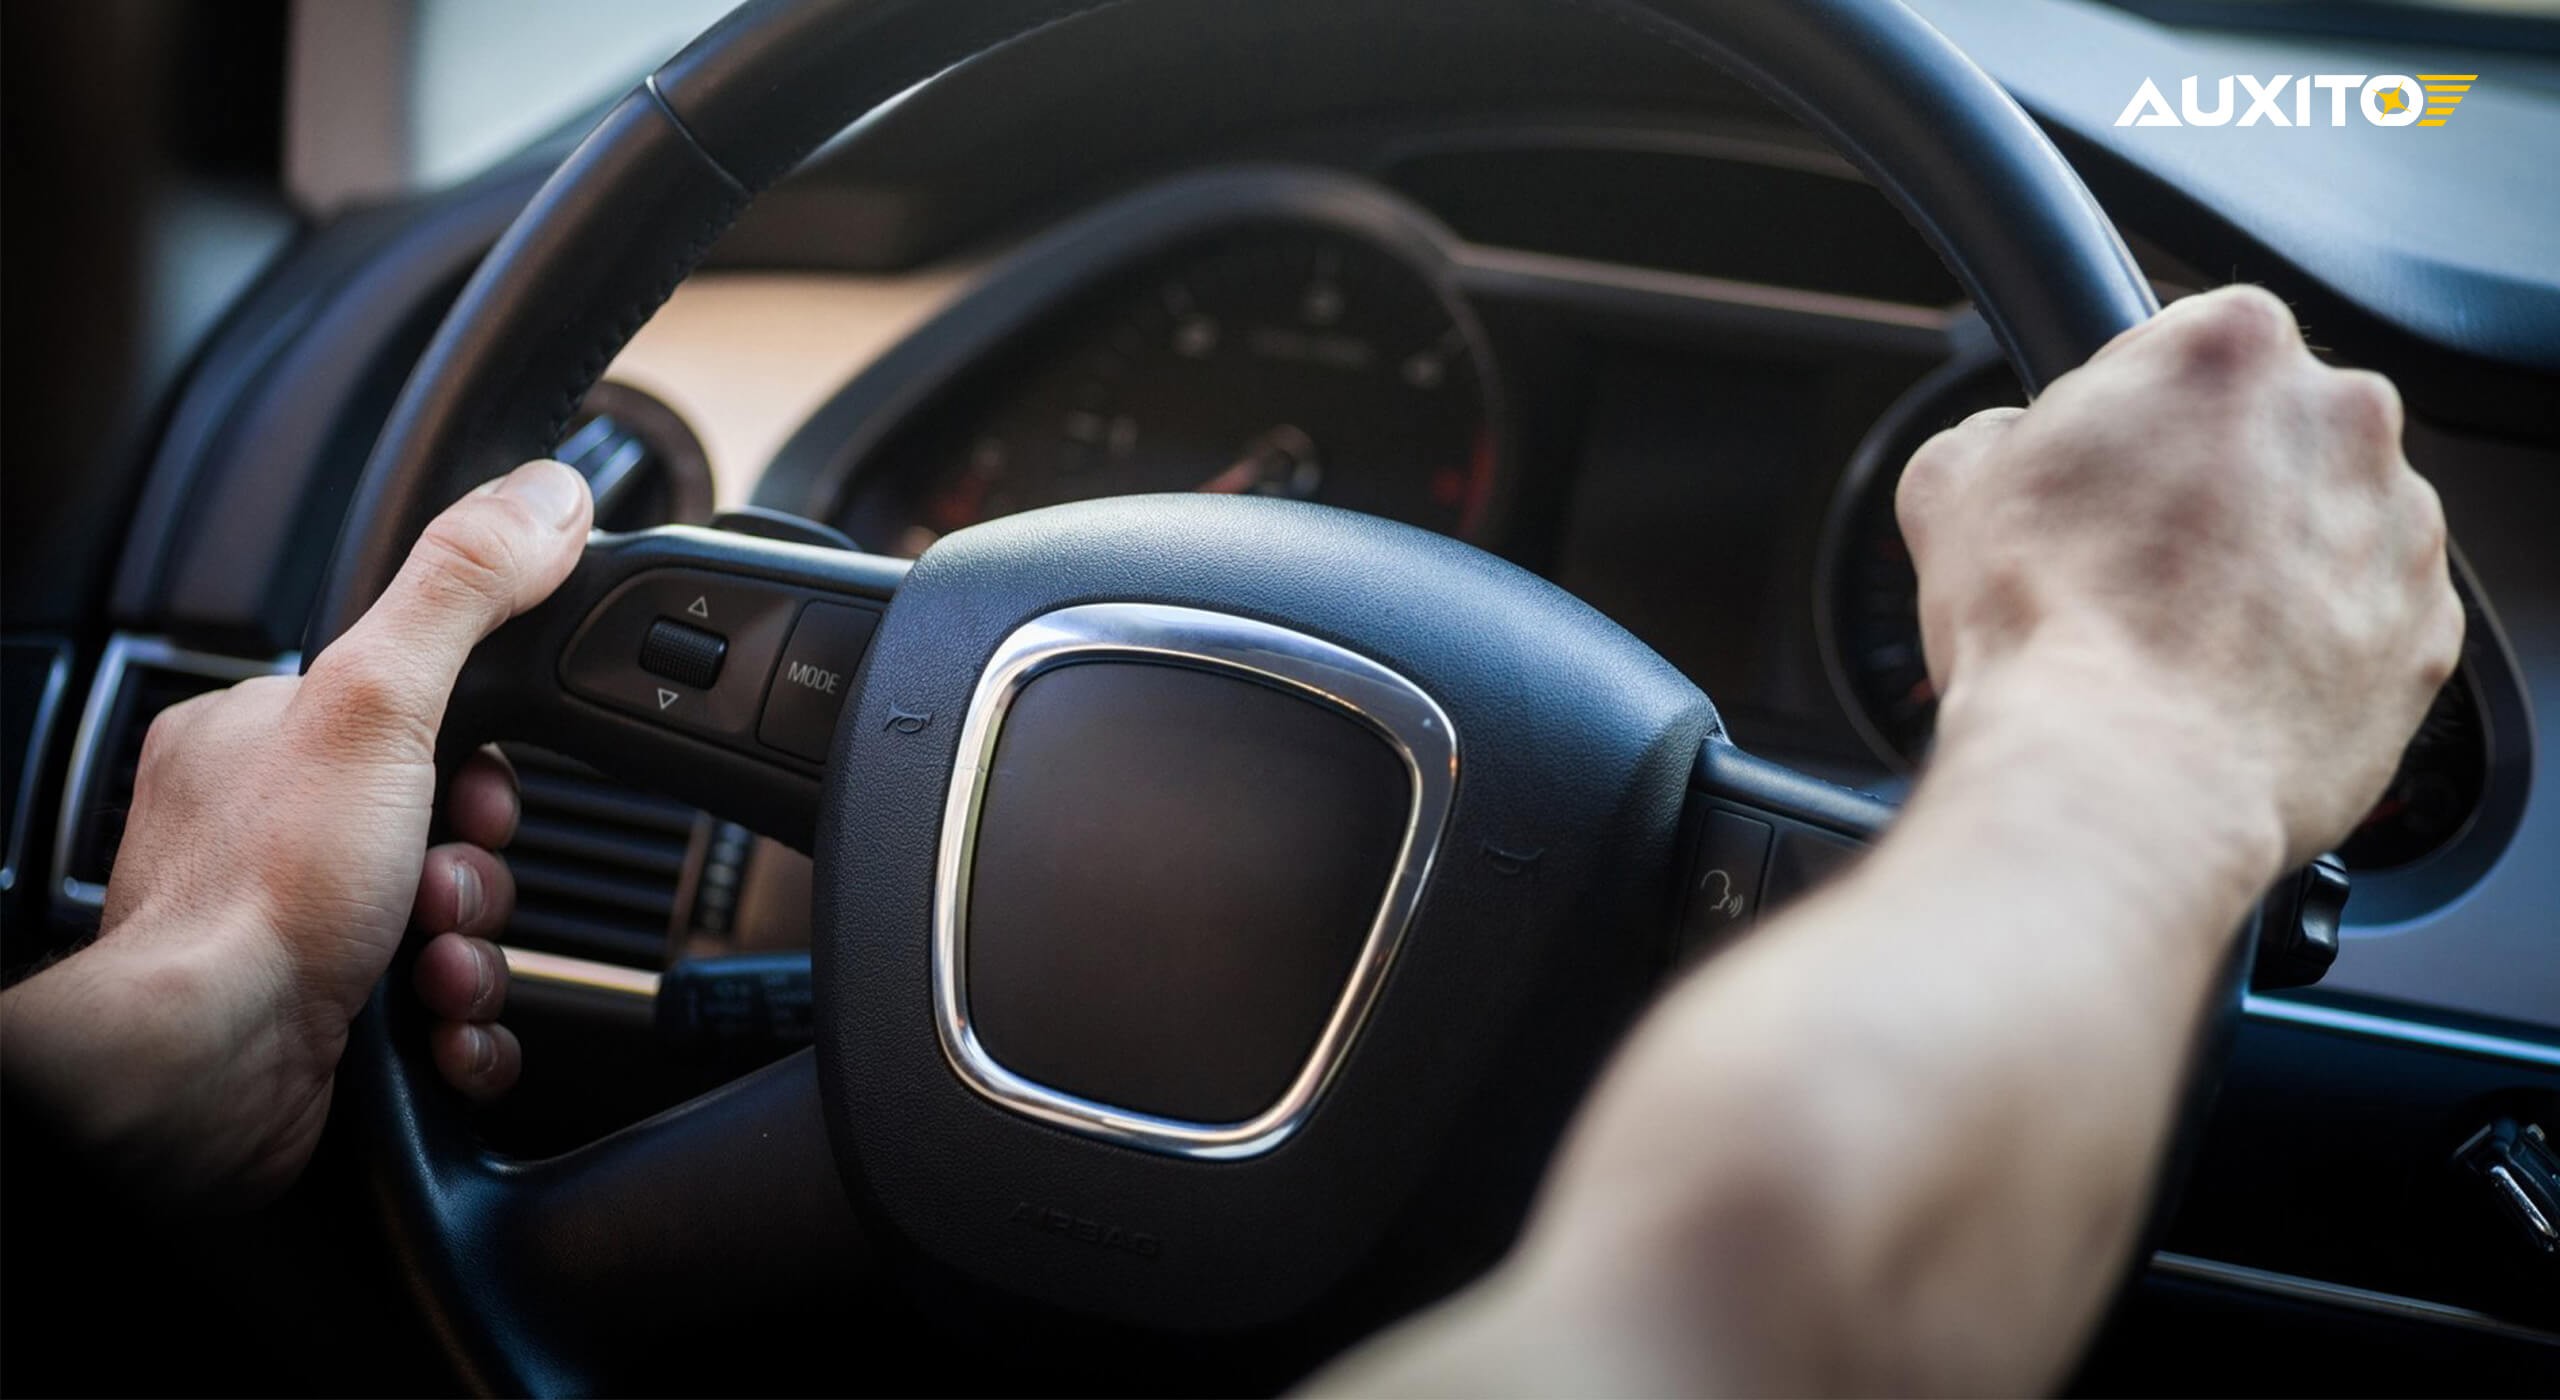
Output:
[{"left": 637, "top": 158, "right": 2522, "bottom": 941}]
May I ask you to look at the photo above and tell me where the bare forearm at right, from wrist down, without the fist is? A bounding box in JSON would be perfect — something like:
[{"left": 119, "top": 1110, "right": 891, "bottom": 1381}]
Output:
[{"left": 1347, "top": 652, "right": 2281, "bottom": 1392}]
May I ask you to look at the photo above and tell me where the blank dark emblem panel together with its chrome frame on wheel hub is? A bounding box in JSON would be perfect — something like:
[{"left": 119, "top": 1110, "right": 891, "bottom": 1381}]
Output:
[{"left": 937, "top": 604, "right": 1457, "bottom": 1157}]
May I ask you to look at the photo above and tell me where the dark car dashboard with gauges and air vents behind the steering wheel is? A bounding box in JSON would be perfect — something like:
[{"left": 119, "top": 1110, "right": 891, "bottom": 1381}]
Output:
[{"left": 0, "top": 0, "right": 2560, "bottom": 1385}]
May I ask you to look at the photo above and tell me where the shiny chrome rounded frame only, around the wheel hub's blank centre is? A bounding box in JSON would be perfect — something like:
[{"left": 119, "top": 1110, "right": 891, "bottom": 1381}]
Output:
[{"left": 932, "top": 604, "right": 1459, "bottom": 1162}]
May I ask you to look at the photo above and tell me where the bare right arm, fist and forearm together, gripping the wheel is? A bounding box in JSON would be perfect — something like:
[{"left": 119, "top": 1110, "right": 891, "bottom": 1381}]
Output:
[{"left": 1324, "top": 289, "right": 2463, "bottom": 1395}]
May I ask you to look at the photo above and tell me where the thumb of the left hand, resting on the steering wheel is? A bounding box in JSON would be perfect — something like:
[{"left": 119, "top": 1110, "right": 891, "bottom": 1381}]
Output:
[{"left": 305, "top": 461, "right": 594, "bottom": 750}]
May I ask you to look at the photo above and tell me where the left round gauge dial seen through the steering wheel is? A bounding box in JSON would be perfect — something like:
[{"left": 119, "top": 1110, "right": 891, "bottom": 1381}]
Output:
[{"left": 842, "top": 225, "right": 1500, "bottom": 555}]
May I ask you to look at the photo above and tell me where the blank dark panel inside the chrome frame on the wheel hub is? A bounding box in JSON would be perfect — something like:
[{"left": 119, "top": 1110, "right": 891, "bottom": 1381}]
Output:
[{"left": 965, "top": 663, "right": 1413, "bottom": 1124}]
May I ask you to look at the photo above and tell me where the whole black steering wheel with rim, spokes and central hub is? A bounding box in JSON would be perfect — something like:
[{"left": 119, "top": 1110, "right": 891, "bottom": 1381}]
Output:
[{"left": 307, "top": 0, "right": 2156, "bottom": 1392}]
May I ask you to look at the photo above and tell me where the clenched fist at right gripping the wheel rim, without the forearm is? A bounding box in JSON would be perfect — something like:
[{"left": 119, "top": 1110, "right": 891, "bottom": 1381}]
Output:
[{"left": 1897, "top": 287, "right": 2463, "bottom": 865}]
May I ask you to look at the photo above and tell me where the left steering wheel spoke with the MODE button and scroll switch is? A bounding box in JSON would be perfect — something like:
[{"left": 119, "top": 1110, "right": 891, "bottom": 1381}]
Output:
[{"left": 440, "top": 527, "right": 906, "bottom": 850}]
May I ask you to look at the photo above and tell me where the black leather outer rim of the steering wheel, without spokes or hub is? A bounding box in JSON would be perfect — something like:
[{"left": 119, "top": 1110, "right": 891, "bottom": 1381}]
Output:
[{"left": 305, "top": 0, "right": 2156, "bottom": 1390}]
